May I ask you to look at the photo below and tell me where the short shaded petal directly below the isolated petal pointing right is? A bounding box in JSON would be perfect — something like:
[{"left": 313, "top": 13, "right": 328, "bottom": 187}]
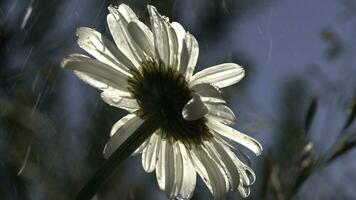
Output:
[{"left": 191, "top": 83, "right": 226, "bottom": 103}]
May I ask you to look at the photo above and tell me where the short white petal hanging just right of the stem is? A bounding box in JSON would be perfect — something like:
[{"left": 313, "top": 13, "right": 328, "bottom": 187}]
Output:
[{"left": 142, "top": 133, "right": 161, "bottom": 173}]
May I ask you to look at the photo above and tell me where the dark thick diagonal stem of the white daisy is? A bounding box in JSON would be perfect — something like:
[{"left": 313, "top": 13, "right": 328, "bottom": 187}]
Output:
[{"left": 75, "top": 114, "right": 164, "bottom": 200}]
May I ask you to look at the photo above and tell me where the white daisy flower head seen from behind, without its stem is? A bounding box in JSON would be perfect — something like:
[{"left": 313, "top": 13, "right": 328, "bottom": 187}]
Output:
[{"left": 62, "top": 4, "right": 262, "bottom": 199}]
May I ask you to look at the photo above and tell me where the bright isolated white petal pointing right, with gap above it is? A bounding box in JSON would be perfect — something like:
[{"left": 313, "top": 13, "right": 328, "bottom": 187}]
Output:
[{"left": 190, "top": 63, "right": 245, "bottom": 88}]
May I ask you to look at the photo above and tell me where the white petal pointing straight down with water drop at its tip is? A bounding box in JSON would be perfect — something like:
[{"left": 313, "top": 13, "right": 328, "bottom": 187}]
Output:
[{"left": 170, "top": 141, "right": 197, "bottom": 199}]
